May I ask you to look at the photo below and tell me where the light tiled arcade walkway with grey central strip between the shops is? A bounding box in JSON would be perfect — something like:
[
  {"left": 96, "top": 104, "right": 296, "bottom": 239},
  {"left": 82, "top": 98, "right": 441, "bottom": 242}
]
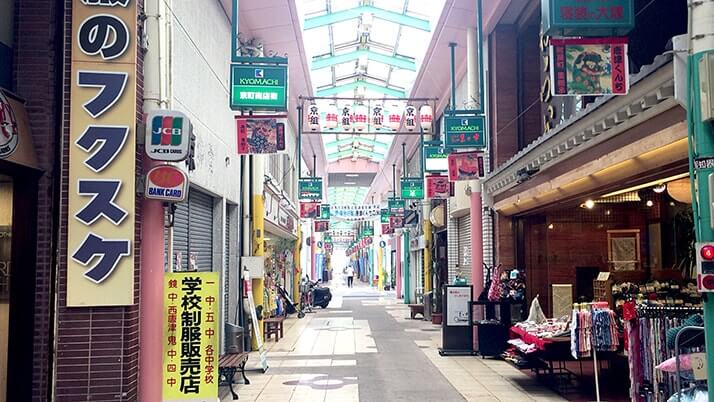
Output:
[{"left": 221, "top": 276, "right": 565, "bottom": 402}]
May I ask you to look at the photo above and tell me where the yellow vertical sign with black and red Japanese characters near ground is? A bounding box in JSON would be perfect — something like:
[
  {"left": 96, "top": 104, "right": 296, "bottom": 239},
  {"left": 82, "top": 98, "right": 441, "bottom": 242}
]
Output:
[{"left": 162, "top": 272, "right": 219, "bottom": 401}]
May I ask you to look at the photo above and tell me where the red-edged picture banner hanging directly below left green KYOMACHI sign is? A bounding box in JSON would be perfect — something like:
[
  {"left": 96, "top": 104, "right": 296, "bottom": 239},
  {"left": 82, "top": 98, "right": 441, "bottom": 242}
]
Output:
[{"left": 236, "top": 117, "right": 287, "bottom": 155}]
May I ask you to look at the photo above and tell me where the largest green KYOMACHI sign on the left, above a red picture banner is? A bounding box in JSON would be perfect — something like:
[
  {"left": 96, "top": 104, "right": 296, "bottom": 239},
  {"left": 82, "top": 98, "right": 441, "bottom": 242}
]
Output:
[{"left": 230, "top": 64, "right": 288, "bottom": 111}]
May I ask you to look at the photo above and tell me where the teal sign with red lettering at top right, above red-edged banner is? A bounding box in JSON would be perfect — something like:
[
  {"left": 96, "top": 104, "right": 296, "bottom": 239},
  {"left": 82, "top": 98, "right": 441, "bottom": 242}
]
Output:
[{"left": 541, "top": 0, "right": 635, "bottom": 37}]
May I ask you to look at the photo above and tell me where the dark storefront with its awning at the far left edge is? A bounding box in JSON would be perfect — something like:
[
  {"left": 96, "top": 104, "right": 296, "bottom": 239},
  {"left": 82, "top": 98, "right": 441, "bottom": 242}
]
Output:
[{"left": 0, "top": 89, "right": 42, "bottom": 401}]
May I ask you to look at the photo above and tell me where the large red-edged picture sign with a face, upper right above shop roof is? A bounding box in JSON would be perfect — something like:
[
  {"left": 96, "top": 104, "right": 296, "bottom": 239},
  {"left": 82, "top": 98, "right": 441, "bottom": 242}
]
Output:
[{"left": 550, "top": 38, "right": 630, "bottom": 96}]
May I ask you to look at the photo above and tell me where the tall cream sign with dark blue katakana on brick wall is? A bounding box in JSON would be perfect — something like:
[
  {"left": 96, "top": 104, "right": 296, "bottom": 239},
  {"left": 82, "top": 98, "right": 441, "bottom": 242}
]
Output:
[{"left": 67, "top": 0, "right": 137, "bottom": 306}]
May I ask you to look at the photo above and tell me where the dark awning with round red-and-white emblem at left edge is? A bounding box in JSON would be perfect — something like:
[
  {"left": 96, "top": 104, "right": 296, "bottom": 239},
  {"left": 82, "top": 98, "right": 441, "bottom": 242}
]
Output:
[{"left": 0, "top": 88, "right": 40, "bottom": 170}]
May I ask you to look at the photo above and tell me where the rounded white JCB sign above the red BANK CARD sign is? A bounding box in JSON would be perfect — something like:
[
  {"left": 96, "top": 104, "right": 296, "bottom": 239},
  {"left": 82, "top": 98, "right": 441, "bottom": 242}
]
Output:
[{"left": 144, "top": 110, "right": 192, "bottom": 162}]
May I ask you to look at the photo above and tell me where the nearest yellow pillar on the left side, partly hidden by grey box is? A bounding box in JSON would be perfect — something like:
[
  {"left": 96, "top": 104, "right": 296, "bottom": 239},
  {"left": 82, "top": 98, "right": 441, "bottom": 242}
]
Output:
[{"left": 251, "top": 155, "right": 266, "bottom": 350}]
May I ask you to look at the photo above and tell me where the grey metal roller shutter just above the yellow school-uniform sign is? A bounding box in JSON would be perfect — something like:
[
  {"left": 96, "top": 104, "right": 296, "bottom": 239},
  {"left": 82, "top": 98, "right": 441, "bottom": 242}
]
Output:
[{"left": 188, "top": 189, "right": 213, "bottom": 271}]
